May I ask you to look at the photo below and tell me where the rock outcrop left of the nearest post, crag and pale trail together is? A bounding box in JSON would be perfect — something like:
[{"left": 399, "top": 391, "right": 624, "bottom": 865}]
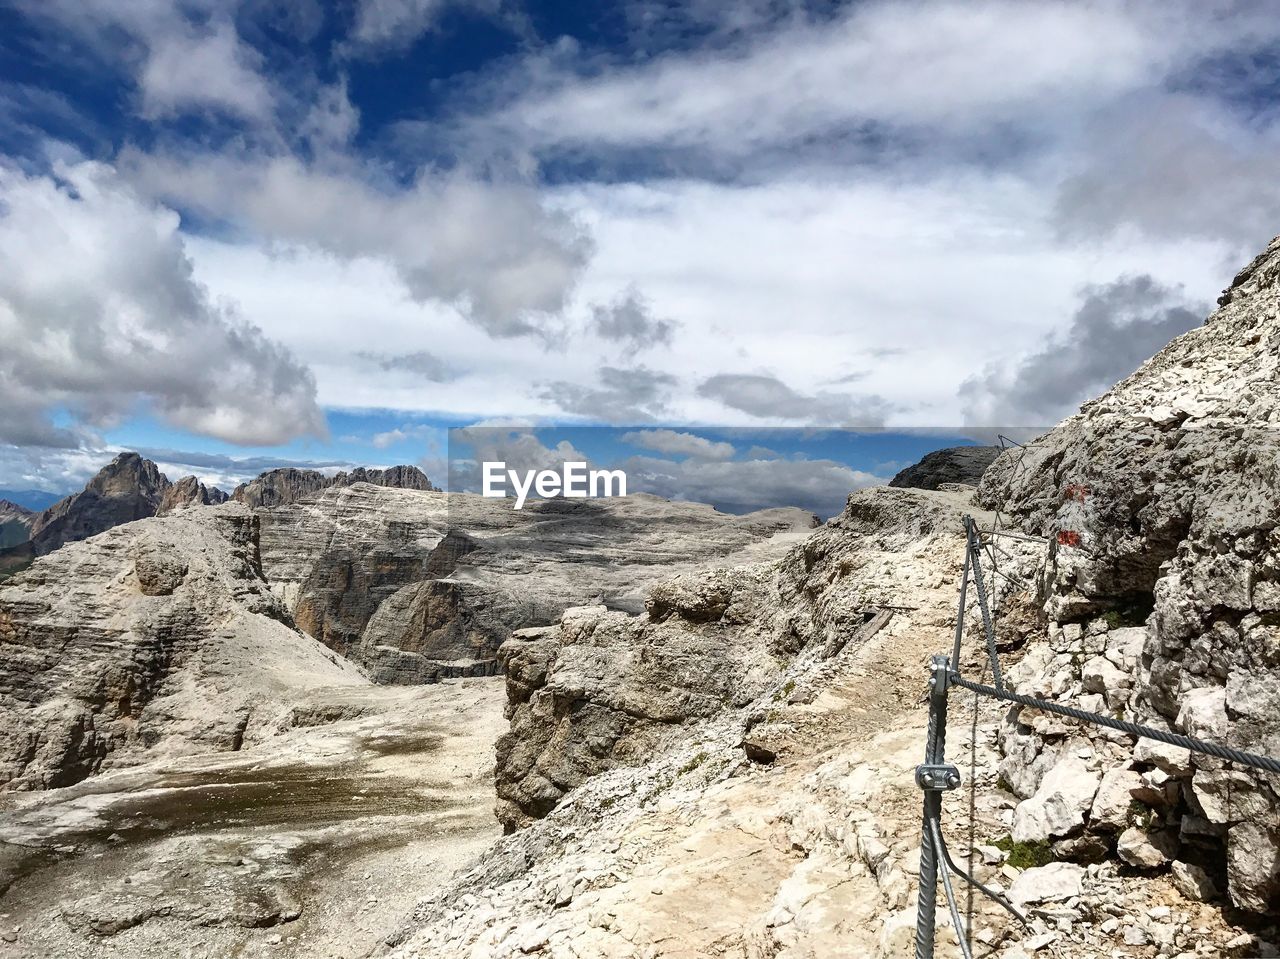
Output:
[{"left": 376, "top": 488, "right": 1070, "bottom": 959}]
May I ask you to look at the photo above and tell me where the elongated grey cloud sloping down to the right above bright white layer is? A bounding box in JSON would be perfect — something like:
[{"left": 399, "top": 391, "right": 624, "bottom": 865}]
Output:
[{"left": 122, "top": 150, "right": 591, "bottom": 337}]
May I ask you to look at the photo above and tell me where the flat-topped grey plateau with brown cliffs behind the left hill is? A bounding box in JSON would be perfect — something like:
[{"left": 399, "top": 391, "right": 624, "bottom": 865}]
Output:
[{"left": 257, "top": 483, "right": 814, "bottom": 682}]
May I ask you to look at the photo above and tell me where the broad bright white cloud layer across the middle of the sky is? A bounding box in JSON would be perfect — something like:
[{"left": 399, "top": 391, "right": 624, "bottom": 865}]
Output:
[{"left": 180, "top": 172, "right": 1240, "bottom": 425}]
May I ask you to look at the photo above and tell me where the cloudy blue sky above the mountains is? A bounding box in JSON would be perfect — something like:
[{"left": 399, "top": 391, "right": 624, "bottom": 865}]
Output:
[{"left": 0, "top": 0, "right": 1280, "bottom": 497}]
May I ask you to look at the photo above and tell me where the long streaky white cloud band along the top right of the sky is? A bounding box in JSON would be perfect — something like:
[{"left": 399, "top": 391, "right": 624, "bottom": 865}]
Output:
[{"left": 442, "top": 0, "right": 1280, "bottom": 166}]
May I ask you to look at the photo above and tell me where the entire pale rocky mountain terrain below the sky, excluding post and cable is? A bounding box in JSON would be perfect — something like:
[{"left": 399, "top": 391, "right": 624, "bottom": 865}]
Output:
[{"left": 0, "top": 241, "right": 1280, "bottom": 959}]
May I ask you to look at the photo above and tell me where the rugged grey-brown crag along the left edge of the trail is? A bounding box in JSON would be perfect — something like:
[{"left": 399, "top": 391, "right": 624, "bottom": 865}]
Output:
[{"left": 494, "top": 488, "right": 972, "bottom": 831}]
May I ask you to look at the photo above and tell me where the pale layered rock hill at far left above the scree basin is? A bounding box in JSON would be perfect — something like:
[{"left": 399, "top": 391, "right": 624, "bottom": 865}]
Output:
[{"left": 0, "top": 506, "right": 367, "bottom": 789}]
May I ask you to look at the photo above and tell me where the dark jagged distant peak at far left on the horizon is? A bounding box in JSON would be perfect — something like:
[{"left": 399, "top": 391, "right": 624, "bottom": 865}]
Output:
[{"left": 31, "top": 453, "right": 169, "bottom": 556}]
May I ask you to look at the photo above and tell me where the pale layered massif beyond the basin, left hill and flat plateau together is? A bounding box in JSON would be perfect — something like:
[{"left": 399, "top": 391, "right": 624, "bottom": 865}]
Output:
[{"left": 0, "top": 483, "right": 813, "bottom": 789}]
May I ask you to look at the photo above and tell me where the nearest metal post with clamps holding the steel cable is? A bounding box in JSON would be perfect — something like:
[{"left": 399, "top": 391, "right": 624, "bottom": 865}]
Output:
[{"left": 915, "top": 656, "right": 960, "bottom": 959}]
